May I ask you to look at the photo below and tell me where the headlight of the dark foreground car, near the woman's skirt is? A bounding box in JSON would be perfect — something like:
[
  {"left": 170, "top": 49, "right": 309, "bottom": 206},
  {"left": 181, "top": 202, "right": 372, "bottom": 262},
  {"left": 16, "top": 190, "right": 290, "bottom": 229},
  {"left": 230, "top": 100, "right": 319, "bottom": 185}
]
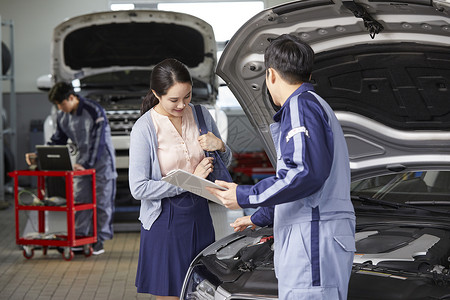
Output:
[{"left": 182, "top": 266, "right": 217, "bottom": 300}]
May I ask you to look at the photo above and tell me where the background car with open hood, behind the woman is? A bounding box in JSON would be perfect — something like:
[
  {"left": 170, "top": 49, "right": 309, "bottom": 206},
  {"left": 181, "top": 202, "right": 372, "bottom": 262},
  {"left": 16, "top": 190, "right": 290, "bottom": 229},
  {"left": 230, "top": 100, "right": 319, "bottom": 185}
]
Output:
[{"left": 38, "top": 10, "right": 228, "bottom": 206}]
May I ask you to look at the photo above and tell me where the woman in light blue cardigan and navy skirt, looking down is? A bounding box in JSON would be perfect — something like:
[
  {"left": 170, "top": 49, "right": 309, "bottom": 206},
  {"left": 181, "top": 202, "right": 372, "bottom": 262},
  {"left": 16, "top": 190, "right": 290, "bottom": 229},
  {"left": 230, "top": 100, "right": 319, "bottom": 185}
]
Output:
[{"left": 129, "top": 59, "right": 231, "bottom": 299}]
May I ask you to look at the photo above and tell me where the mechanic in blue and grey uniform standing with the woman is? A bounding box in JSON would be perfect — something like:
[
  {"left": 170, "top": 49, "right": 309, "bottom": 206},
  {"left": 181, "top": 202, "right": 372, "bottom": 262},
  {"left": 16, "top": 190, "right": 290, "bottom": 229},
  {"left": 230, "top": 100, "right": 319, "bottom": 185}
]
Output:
[{"left": 210, "top": 35, "right": 355, "bottom": 300}]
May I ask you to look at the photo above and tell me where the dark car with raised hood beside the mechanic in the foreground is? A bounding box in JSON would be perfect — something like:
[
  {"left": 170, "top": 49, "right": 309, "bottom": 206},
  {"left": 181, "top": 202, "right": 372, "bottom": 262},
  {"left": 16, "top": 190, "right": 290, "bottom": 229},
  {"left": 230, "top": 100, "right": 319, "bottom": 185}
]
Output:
[{"left": 181, "top": 0, "right": 450, "bottom": 300}]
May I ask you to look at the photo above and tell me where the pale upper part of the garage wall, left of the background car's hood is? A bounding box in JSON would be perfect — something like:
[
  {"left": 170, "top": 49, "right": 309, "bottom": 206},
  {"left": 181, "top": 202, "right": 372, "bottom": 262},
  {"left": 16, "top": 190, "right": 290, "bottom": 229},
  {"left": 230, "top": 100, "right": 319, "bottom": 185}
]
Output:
[{"left": 0, "top": 0, "right": 108, "bottom": 93}]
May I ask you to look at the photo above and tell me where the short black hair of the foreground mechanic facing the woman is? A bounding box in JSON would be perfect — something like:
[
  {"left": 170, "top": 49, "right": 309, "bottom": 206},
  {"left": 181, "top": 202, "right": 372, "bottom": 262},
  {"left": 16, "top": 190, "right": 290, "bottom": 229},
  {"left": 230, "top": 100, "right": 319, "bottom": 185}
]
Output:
[{"left": 264, "top": 34, "right": 314, "bottom": 84}]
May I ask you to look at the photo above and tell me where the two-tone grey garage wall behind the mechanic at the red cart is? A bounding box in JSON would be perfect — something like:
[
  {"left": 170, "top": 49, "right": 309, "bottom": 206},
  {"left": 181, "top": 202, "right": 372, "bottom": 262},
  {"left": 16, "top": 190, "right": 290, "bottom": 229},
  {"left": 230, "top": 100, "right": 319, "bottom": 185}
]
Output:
[{"left": 0, "top": 0, "right": 108, "bottom": 176}]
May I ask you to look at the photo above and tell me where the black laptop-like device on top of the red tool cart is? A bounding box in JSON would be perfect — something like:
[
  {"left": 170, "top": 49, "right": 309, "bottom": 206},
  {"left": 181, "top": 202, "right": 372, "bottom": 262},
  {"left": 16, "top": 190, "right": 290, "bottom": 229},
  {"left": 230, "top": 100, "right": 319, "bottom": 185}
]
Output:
[{"left": 36, "top": 145, "right": 73, "bottom": 171}]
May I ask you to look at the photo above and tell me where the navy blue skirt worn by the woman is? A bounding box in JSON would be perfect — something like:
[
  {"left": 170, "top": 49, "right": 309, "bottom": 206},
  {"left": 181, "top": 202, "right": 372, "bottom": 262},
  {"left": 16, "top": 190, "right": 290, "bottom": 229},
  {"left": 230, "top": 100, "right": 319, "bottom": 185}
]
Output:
[{"left": 136, "top": 192, "right": 215, "bottom": 297}]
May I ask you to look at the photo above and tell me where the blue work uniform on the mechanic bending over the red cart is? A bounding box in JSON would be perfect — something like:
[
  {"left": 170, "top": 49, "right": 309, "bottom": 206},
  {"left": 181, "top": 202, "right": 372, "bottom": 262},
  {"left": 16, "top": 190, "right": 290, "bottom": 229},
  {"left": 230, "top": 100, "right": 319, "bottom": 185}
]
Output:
[{"left": 48, "top": 97, "right": 117, "bottom": 242}]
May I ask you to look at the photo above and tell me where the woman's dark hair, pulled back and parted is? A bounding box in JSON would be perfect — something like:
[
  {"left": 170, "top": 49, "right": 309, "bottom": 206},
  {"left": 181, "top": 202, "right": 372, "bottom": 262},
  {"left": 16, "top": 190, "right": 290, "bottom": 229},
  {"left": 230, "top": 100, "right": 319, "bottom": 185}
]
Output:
[{"left": 141, "top": 58, "right": 192, "bottom": 116}]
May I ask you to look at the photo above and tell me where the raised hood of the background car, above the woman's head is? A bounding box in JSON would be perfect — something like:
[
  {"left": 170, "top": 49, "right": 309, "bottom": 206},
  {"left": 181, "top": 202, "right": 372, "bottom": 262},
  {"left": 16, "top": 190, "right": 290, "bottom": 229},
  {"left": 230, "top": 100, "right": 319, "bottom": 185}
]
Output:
[{"left": 51, "top": 10, "right": 218, "bottom": 99}]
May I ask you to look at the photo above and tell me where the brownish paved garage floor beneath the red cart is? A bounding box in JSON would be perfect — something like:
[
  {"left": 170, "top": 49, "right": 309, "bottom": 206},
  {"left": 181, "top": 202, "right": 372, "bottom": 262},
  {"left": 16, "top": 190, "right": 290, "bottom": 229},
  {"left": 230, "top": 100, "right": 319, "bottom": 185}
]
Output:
[{"left": 0, "top": 195, "right": 242, "bottom": 300}]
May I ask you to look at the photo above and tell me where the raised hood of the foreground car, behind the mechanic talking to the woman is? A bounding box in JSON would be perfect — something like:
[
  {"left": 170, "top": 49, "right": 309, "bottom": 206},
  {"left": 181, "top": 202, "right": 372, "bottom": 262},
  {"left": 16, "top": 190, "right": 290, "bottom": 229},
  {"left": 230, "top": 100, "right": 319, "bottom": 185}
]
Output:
[{"left": 216, "top": 0, "right": 450, "bottom": 178}]
